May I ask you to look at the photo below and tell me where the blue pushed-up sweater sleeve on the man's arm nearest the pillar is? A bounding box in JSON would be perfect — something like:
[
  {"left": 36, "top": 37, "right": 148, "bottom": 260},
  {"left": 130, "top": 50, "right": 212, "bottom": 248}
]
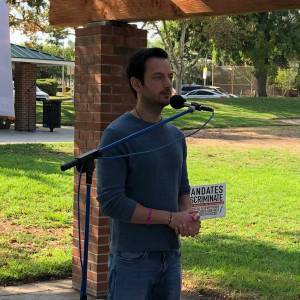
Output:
[{"left": 96, "top": 129, "right": 137, "bottom": 222}]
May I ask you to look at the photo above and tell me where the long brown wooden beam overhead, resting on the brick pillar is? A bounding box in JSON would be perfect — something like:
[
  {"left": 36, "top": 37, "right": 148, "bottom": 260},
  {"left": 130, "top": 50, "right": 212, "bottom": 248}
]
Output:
[{"left": 50, "top": 0, "right": 300, "bottom": 26}]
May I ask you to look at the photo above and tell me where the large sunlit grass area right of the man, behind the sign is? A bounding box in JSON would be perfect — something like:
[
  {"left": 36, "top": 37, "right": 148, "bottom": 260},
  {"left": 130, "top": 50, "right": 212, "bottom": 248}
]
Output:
[{"left": 182, "top": 146, "right": 300, "bottom": 300}]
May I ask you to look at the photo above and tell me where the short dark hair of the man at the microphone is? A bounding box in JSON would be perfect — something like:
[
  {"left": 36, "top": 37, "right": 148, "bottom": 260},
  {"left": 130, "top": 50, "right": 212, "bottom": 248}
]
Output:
[{"left": 127, "top": 48, "right": 168, "bottom": 98}]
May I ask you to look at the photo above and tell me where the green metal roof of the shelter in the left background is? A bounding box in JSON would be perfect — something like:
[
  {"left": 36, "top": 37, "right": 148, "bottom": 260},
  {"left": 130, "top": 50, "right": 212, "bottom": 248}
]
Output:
[{"left": 10, "top": 44, "right": 74, "bottom": 66}]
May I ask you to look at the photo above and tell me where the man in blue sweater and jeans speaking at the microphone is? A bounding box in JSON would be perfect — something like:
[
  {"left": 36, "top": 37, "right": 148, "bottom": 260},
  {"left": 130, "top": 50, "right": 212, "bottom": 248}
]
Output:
[{"left": 97, "top": 48, "right": 200, "bottom": 300}]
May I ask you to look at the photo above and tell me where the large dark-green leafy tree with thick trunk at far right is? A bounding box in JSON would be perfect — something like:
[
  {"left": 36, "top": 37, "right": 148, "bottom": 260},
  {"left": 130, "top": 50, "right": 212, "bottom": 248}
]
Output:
[{"left": 214, "top": 10, "right": 300, "bottom": 97}]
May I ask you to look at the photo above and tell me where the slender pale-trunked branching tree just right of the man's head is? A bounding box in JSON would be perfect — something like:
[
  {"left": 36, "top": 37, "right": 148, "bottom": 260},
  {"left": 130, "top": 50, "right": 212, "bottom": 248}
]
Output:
[{"left": 147, "top": 17, "right": 226, "bottom": 93}]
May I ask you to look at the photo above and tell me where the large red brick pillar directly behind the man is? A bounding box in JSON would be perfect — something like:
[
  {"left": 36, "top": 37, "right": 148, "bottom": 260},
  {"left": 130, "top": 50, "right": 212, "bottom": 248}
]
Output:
[{"left": 72, "top": 22, "right": 147, "bottom": 297}]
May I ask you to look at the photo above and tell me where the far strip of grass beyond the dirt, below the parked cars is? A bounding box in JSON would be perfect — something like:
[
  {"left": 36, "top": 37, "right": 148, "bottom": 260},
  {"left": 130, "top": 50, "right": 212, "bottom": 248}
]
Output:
[{"left": 163, "top": 98, "right": 300, "bottom": 129}]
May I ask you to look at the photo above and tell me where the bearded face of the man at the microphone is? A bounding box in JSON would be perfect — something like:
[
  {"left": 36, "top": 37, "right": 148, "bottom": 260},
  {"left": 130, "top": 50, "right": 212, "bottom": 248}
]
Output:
[{"left": 140, "top": 57, "right": 173, "bottom": 107}]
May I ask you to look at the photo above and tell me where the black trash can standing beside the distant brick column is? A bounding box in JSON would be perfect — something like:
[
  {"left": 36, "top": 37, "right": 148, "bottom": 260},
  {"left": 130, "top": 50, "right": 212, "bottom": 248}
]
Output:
[{"left": 43, "top": 100, "right": 61, "bottom": 132}]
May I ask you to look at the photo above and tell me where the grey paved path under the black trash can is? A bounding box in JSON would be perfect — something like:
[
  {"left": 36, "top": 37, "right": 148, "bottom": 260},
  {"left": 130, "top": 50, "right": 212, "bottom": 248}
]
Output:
[{"left": 0, "top": 124, "right": 74, "bottom": 144}]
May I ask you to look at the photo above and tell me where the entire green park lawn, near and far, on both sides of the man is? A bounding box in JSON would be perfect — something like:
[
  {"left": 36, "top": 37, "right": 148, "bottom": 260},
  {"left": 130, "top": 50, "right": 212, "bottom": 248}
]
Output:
[{"left": 0, "top": 99, "right": 300, "bottom": 300}]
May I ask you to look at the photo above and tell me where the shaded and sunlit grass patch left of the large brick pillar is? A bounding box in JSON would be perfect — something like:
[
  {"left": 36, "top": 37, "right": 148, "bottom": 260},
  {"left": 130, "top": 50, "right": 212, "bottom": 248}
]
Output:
[{"left": 0, "top": 143, "right": 73, "bottom": 284}]
